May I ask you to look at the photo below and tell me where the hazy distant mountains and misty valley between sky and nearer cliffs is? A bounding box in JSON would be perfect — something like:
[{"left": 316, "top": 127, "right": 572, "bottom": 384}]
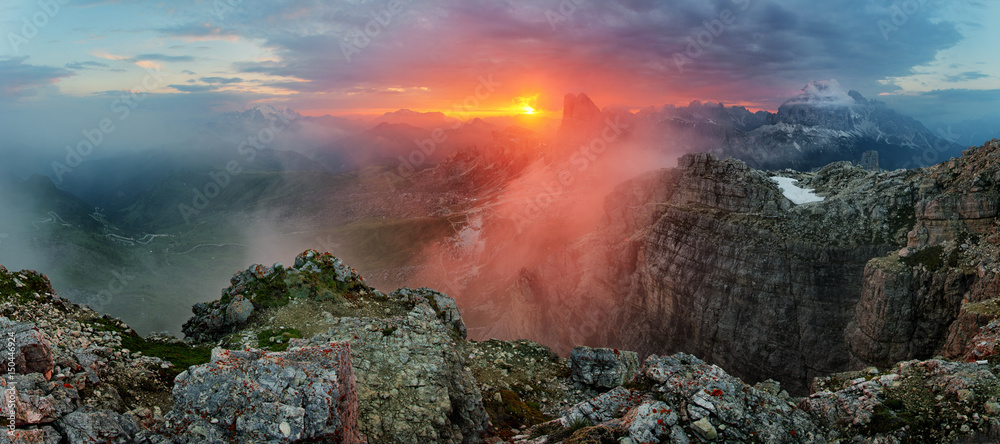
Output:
[{"left": 0, "top": 82, "right": 980, "bottom": 342}]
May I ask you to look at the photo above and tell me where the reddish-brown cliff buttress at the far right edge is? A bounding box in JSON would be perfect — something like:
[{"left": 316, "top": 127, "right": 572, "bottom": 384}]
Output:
[{"left": 847, "top": 140, "right": 1000, "bottom": 365}]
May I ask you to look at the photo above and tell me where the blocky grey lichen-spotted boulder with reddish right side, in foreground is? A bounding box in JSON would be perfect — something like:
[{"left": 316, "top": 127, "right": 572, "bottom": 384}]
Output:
[{"left": 140, "top": 342, "right": 363, "bottom": 443}]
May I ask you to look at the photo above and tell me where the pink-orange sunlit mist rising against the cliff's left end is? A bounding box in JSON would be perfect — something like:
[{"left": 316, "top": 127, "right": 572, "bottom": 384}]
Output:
[{"left": 402, "top": 102, "right": 683, "bottom": 354}]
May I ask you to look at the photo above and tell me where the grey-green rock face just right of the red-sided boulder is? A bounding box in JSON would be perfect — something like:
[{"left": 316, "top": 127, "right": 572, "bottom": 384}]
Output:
[{"left": 304, "top": 298, "right": 488, "bottom": 443}]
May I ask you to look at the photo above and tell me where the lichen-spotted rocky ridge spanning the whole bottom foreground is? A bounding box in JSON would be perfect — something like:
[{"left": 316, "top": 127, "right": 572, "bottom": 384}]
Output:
[{"left": 0, "top": 245, "right": 1000, "bottom": 444}]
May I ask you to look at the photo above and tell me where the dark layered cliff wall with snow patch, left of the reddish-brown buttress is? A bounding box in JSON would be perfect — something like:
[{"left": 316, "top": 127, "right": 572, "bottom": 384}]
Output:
[{"left": 496, "top": 154, "right": 915, "bottom": 393}]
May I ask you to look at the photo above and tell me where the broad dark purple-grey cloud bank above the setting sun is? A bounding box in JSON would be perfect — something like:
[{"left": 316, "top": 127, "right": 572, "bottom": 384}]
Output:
[{"left": 163, "top": 0, "right": 961, "bottom": 107}]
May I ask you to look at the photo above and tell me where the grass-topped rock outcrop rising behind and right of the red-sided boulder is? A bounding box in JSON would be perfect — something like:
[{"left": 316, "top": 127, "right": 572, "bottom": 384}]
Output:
[{"left": 175, "top": 250, "right": 488, "bottom": 443}]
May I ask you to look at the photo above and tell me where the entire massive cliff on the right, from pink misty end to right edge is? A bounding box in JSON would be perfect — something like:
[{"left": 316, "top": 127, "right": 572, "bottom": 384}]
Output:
[{"left": 491, "top": 142, "right": 1000, "bottom": 393}]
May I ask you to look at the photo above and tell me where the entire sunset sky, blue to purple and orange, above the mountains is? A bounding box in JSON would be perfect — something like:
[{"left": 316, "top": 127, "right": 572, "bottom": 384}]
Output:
[{"left": 0, "top": 0, "right": 1000, "bottom": 119}]
